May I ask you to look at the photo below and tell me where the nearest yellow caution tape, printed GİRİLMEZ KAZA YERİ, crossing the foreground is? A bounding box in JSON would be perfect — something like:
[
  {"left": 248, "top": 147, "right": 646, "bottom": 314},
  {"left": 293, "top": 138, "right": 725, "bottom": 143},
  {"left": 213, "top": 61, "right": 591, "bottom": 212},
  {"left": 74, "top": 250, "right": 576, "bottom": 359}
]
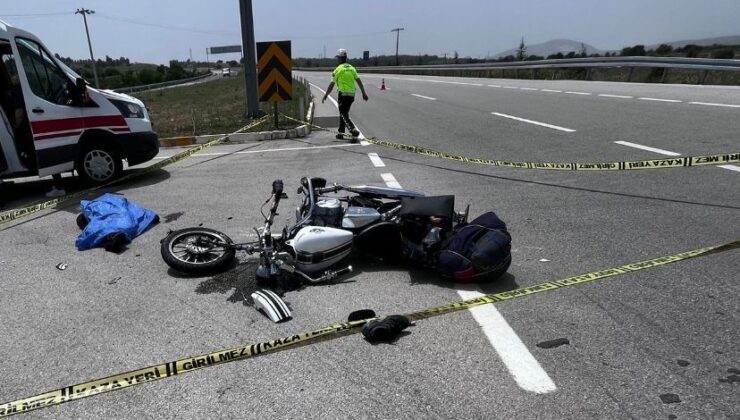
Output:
[{"left": 0, "top": 240, "right": 740, "bottom": 418}]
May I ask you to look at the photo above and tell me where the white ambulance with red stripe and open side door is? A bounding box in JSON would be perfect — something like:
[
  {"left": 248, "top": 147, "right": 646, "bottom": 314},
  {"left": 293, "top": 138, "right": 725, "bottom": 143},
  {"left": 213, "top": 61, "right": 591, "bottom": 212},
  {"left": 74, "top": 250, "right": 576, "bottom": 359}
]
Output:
[{"left": 0, "top": 20, "right": 159, "bottom": 184}]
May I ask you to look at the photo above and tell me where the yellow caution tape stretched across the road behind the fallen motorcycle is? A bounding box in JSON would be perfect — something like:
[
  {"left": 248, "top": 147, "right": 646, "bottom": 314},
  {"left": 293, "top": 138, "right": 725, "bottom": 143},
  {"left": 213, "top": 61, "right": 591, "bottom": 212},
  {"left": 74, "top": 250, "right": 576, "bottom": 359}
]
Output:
[{"left": 285, "top": 116, "right": 740, "bottom": 171}]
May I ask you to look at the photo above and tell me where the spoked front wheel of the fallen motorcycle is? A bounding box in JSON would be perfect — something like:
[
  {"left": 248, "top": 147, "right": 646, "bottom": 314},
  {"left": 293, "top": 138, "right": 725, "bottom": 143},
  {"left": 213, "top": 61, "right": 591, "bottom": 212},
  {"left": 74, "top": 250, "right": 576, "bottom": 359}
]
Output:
[{"left": 160, "top": 227, "right": 236, "bottom": 274}]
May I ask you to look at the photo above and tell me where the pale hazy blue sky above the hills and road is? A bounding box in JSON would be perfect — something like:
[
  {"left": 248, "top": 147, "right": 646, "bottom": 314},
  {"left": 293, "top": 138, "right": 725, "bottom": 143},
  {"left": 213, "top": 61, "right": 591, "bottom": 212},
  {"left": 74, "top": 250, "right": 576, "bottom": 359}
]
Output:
[{"left": 0, "top": 0, "right": 740, "bottom": 64}]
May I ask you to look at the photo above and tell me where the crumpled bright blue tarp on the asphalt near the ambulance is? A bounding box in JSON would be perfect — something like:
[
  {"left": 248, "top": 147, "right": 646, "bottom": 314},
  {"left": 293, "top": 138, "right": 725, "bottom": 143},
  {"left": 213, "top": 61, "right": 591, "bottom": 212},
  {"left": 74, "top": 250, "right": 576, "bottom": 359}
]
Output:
[{"left": 75, "top": 193, "right": 159, "bottom": 251}]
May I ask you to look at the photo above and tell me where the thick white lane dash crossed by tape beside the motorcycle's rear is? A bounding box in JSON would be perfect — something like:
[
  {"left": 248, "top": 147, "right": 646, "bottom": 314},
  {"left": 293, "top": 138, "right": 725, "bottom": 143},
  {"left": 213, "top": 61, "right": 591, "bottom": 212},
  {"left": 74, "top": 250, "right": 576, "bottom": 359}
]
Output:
[{"left": 457, "top": 285, "right": 558, "bottom": 394}]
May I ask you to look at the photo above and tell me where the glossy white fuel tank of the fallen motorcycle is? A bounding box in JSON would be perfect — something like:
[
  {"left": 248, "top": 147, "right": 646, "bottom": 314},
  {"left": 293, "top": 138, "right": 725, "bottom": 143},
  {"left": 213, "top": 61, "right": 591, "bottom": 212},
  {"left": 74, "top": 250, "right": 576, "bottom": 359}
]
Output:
[{"left": 287, "top": 226, "right": 353, "bottom": 272}]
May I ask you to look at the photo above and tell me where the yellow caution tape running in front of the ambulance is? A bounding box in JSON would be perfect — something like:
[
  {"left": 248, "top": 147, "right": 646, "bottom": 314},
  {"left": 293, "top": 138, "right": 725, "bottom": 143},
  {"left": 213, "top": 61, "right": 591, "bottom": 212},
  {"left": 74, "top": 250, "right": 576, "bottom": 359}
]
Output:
[{"left": 0, "top": 116, "right": 267, "bottom": 225}]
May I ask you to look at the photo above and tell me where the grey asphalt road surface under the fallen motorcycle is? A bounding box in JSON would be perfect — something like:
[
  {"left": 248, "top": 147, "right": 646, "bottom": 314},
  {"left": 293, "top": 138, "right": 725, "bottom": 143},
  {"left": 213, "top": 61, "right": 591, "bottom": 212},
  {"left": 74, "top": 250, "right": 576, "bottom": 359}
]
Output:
[{"left": 0, "top": 73, "right": 740, "bottom": 419}]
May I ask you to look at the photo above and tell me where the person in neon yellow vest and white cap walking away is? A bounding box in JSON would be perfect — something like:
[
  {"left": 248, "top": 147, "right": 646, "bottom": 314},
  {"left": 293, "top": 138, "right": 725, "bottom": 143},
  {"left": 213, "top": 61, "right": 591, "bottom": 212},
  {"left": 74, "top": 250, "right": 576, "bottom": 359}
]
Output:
[{"left": 321, "top": 48, "right": 367, "bottom": 140}]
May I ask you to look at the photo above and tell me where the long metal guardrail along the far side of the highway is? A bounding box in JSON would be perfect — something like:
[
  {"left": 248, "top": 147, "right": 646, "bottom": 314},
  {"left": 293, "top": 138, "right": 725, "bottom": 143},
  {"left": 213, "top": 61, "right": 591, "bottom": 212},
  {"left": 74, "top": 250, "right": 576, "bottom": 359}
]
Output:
[{"left": 294, "top": 57, "right": 740, "bottom": 83}]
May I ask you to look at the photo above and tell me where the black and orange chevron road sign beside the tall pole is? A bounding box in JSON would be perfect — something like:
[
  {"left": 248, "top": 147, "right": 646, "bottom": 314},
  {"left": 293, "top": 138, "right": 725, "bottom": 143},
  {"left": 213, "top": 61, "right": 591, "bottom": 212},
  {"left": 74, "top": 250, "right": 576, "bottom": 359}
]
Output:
[{"left": 257, "top": 41, "right": 293, "bottom": 102}]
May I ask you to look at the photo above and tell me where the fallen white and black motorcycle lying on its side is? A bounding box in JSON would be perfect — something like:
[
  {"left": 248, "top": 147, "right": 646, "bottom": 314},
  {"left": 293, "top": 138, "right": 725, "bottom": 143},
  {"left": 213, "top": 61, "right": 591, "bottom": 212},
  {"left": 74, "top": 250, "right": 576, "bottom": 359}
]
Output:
[{"left": 161, "top": 177, "right": 511, "bottom": 283}]
